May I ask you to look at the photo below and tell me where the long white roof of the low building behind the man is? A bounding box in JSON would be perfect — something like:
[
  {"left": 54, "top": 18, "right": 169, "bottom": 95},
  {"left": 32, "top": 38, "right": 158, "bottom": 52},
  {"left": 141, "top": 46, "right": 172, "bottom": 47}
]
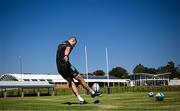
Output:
[{"left": 0, "top": 74, "right": 129, "bottom": 82}]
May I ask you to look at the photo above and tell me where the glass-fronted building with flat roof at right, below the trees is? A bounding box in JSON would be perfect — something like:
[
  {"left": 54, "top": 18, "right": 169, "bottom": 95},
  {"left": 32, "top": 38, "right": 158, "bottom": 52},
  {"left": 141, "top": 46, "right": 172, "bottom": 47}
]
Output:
[{"left": 130, "top": 73, "right": 171, "bottom": 86}]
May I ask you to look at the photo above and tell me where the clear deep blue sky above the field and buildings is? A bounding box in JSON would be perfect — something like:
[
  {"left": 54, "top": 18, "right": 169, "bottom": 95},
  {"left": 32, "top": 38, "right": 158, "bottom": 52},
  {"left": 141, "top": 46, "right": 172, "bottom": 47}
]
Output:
[{"left": 0, "top": 0, "right": 180, "bottom": 73}]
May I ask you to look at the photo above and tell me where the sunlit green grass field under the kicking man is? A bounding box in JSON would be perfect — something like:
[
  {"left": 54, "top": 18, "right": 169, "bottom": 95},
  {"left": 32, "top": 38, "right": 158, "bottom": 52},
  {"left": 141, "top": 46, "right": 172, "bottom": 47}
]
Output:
[{"left": 0, "top": 92, "right": 180, "bottom": 111}]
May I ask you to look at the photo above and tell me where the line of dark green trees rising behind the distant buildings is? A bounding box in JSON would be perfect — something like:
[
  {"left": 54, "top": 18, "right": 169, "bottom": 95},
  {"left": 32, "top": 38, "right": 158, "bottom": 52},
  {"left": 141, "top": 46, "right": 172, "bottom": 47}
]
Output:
[{"left": 81, "top": 61, "right": 180, "bottom": 79}]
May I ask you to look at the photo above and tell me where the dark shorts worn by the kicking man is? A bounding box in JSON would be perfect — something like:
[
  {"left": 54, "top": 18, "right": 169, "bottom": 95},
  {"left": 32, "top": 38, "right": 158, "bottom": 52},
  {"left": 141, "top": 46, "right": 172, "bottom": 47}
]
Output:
[{"left": 57, "top": 60, "right": 79, "bottom": 81}]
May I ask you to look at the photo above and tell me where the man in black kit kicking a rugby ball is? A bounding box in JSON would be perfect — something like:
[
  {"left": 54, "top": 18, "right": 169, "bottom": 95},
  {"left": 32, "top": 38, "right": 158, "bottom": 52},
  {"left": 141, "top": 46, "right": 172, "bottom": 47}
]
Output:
[{"left": 56, "top": 36, "right": 101, "bottom": 104}]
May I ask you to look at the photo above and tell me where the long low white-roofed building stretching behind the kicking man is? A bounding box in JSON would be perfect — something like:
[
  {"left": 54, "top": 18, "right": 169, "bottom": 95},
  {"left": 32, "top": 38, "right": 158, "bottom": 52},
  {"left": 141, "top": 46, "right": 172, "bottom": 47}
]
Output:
[{"left": 0, "top": 74, "right": 130, "bottom": 88}]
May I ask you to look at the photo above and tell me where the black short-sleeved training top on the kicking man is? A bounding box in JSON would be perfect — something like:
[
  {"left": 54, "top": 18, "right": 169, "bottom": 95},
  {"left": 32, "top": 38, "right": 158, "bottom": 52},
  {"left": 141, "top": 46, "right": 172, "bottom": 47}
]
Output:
[{"left": 56, "top": 41, "right": 73, "bottom": 62}]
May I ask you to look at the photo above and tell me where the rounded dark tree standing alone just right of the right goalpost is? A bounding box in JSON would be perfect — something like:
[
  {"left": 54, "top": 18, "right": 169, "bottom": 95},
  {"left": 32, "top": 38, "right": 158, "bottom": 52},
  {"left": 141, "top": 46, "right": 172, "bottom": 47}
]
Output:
[{"left": 109, "top": 67, "right": 128, "bottom": 79}]
